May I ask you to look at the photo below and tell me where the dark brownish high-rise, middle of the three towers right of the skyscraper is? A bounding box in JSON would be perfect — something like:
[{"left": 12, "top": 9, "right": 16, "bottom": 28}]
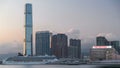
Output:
[{"left": 51, "top": 34, "right": 68, "bottom": 58}]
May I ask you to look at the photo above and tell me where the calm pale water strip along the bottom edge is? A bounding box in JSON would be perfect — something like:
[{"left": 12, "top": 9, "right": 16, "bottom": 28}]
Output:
[{"left": 0, "top": 65, "right": 97, "bottom": 68}]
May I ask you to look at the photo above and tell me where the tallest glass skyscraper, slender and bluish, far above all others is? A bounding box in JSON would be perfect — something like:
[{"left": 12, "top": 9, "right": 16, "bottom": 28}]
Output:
[{"left": 24, "top": 3, "right": 33, "bottom": 56}]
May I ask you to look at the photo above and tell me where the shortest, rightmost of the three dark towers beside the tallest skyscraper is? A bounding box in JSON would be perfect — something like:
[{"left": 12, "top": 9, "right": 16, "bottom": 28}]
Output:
[{"left": 69, "top": 39, "right": 81, "bottom": 59}]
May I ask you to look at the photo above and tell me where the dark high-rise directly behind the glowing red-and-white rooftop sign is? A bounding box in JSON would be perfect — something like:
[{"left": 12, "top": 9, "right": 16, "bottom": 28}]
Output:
[{"left": 96, "top": 36, "right": 109, "bottom": 46}]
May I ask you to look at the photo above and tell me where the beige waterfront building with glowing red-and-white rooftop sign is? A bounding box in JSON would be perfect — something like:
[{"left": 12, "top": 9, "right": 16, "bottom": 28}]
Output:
[{"left": 90, "top": 46, "right": 117, "bottom": 61}]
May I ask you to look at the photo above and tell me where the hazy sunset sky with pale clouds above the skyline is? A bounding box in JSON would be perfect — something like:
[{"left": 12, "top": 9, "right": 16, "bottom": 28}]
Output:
[{"left": 0, "top": 0, "right": 120, "bottom": 54}]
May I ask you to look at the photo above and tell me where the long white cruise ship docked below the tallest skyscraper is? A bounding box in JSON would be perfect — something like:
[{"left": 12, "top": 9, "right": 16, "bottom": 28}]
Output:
[{"left": 2, "top": 56, "right": 58, "bottom": 64}]
